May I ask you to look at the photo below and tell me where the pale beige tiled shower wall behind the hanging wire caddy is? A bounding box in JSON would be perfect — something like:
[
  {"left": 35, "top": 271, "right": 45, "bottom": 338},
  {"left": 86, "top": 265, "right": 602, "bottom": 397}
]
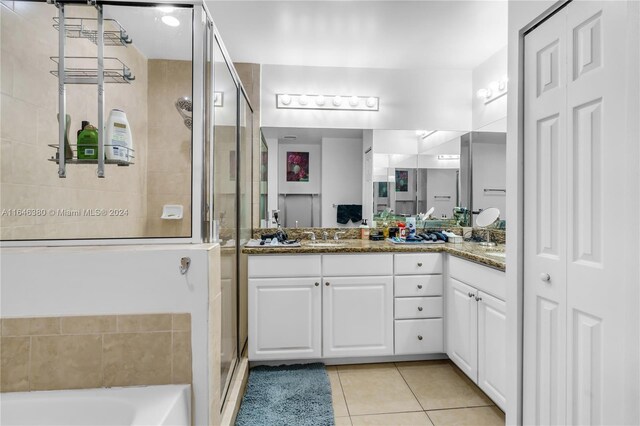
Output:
[{"left": 0, "top": 2, "right": 149, "bottom": 240}]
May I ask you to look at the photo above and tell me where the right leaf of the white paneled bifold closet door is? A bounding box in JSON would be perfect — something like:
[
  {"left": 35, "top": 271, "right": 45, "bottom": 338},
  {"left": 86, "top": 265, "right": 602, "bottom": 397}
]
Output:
[{"left": 566, "top": 1, "right": 638, "bottom": 425}]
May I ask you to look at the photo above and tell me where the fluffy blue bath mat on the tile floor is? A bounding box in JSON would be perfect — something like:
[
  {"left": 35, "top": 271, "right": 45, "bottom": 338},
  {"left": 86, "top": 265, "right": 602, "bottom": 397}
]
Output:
[{"left": 236, "top": 363, "right": 334, "bottom": 426}]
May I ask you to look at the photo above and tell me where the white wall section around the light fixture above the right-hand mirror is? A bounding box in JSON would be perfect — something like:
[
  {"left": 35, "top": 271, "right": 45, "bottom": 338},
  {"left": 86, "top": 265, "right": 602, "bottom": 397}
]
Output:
[{"left": 471, "top": 46, "right": 509, "bottom": 132}]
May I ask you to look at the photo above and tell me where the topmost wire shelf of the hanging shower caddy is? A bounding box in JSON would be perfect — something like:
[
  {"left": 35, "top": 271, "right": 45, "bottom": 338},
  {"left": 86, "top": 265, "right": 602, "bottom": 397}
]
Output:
[{"left": 53, "top": 17, "right": 133, "bottom": 47}]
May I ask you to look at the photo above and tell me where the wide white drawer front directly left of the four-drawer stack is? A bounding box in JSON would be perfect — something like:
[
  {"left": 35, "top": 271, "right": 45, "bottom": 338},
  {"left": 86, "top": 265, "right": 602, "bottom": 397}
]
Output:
[{"left": 322, "top": 253, "right": 393, "bottom": 277}]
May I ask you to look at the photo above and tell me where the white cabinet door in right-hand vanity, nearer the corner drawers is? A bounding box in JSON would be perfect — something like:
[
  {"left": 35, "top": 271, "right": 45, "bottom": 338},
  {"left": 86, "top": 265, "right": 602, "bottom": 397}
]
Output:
[{"left": 446, "top": 278, "right": 478, "bottom": 382}]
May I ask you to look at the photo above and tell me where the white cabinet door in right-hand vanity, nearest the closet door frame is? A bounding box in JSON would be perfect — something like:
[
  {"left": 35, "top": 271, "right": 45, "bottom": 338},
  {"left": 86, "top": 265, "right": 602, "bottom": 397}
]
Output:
[{"left": 478, "top": 292, "right": 507, "bottom": 410}]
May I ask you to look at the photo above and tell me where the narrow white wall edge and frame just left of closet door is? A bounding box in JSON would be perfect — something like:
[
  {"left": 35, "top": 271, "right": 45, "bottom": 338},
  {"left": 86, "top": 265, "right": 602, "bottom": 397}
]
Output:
[{"left": 506, "top": 0, "right": 556, "bottom": 425}]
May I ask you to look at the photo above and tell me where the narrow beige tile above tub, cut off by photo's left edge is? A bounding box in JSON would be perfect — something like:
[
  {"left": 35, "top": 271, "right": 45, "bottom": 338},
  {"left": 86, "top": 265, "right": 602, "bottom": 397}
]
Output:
[{"left": 0, "top": 337, "right": 31, "bottom": 392}]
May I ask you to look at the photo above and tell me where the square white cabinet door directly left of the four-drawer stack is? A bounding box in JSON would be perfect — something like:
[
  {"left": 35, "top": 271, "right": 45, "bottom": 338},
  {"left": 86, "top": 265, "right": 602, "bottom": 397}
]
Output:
[{"left": 322, "top": 277, "right": 393, "bottom": 357}]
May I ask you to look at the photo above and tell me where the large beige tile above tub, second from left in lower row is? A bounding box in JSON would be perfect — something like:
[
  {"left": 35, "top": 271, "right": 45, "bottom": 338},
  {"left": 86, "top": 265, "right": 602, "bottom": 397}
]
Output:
[{"left": 31, "top": 335, "right": 102, "bottom": 390}]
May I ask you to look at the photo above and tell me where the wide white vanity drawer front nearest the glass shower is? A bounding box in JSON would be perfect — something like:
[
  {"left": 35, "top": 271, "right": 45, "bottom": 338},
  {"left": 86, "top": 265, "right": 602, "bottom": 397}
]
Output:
[{"left": 249, "top": 254, "right": 321, "bottom": 278}]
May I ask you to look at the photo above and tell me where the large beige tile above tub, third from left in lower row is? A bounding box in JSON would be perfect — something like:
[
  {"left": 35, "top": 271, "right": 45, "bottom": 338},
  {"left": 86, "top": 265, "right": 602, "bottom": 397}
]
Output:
[{"left": 103, "top": 332, "right": 172, "bottom": 386}]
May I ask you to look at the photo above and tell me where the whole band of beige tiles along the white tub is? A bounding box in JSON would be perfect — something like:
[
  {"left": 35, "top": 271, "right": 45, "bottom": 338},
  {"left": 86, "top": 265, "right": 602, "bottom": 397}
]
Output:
[{"left": 0, "top": 313, "right": 192, "bottom": 392}]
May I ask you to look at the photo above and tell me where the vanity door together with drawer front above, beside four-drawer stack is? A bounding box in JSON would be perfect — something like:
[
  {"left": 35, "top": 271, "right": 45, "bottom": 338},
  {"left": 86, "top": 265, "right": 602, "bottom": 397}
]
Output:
[{"left": 322, "top": 253, "right": 393, "bottom": 358}]
